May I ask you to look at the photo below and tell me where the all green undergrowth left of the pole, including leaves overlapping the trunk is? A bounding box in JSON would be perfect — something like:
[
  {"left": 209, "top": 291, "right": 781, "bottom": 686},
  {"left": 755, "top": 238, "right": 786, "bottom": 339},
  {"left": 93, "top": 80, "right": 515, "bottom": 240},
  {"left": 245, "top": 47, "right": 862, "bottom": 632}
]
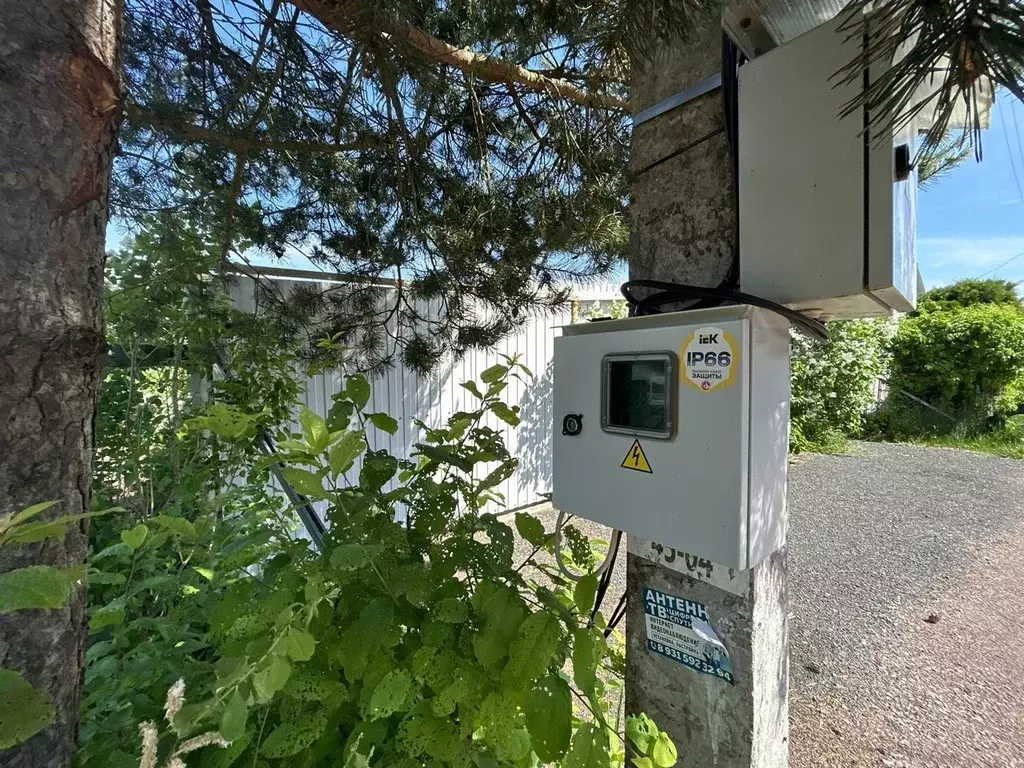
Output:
[{"left": 0, "top": 234, "right": 677, "bottom": 768}]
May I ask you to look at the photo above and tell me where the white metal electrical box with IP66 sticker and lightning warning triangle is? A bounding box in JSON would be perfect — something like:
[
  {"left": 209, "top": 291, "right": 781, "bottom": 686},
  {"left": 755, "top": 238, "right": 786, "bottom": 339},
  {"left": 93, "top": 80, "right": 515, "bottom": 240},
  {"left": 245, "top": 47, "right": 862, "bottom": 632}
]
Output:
[{"left": 553, "top": 306, "right": 790, "bottom": 569}]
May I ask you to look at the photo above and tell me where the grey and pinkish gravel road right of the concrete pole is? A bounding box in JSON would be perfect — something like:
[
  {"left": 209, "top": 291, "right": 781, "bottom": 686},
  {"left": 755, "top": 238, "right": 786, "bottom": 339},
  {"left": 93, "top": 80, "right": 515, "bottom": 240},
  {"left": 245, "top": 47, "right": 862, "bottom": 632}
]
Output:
[{"left": 516, "top": 443, "right": 1024, "bottom": 768}]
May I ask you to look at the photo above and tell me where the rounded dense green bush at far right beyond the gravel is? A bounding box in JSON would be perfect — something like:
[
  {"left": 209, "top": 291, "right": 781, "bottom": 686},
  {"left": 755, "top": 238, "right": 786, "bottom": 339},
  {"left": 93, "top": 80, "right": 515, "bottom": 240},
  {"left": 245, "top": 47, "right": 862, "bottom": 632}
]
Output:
[{"left": 891, "top": 304, "right": 1024, "bottom": 429}]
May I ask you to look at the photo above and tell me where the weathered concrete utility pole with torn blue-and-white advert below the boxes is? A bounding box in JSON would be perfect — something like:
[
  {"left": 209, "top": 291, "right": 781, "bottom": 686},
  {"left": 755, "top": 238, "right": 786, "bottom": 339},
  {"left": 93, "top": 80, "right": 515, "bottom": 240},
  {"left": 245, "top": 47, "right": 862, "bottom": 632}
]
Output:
[{"left": 626, "top": 22, "right": 788, "bottom": 768}]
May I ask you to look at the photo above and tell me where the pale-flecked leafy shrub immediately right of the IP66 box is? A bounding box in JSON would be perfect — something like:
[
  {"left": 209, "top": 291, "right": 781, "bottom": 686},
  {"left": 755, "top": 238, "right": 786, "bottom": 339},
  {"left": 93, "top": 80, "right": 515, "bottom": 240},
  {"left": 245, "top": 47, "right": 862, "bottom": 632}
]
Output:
[{"left": 791, "top": 321, "right": 894, "bottom": 453}]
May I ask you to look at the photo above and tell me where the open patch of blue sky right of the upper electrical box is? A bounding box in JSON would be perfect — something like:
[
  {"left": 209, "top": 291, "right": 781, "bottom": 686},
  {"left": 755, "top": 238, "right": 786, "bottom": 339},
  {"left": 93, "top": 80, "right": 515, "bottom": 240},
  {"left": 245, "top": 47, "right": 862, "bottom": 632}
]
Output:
[{"left": 918, "top": 92, "right": 1024, "bottom": 288}]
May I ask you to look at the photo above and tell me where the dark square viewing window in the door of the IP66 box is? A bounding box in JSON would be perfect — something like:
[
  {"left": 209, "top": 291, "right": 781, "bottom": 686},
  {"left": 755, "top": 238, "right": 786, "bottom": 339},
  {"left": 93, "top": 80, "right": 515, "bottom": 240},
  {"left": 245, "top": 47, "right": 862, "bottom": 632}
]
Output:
[{"left": 601, "top": 352, "right": 679, "bottom": 440}]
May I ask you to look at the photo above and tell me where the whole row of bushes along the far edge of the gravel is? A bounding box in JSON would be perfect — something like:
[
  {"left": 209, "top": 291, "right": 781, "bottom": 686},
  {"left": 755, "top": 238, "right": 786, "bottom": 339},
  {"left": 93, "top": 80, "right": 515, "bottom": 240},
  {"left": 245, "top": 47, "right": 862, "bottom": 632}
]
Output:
[{"left": 792, "top": 280, "right": 1024, "bottom": 458}]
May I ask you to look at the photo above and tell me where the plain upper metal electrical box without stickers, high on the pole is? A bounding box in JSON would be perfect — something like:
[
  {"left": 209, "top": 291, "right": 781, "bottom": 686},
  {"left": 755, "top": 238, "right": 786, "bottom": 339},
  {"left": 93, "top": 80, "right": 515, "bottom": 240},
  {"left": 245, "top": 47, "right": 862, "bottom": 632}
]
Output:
[{"left": 739, "top": 14, "right": 918, "bottom": 318}]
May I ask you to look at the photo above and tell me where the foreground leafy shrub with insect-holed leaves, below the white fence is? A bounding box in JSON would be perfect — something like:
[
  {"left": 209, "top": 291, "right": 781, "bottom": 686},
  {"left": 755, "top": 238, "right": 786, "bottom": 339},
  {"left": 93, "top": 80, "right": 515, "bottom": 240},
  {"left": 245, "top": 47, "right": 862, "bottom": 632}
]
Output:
[{"left": 79, "top": 358, "right": 676, "bottom": 768}]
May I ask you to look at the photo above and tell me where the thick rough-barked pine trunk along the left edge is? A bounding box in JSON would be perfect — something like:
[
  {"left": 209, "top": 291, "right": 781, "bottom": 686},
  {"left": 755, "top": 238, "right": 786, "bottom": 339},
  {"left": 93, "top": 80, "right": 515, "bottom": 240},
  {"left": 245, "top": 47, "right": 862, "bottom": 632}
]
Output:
[{"left": 0, "top": 0, "right": 121, "bottom": 768}]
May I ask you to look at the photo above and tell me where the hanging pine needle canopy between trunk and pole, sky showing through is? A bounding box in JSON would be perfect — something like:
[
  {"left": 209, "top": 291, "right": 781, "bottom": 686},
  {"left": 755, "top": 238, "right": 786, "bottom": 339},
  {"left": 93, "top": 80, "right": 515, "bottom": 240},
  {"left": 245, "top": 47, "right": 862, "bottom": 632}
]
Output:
[{"left": 113, "top": 0, "right": 718, "bottom": 369}]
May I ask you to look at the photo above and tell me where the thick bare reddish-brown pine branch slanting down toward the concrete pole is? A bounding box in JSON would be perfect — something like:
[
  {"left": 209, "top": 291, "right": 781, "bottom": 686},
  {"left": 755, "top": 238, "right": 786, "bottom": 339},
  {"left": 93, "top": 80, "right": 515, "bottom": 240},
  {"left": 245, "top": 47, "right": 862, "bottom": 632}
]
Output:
[{"left": 291, "top": 0, "right": 629, "bottom": 110}]
